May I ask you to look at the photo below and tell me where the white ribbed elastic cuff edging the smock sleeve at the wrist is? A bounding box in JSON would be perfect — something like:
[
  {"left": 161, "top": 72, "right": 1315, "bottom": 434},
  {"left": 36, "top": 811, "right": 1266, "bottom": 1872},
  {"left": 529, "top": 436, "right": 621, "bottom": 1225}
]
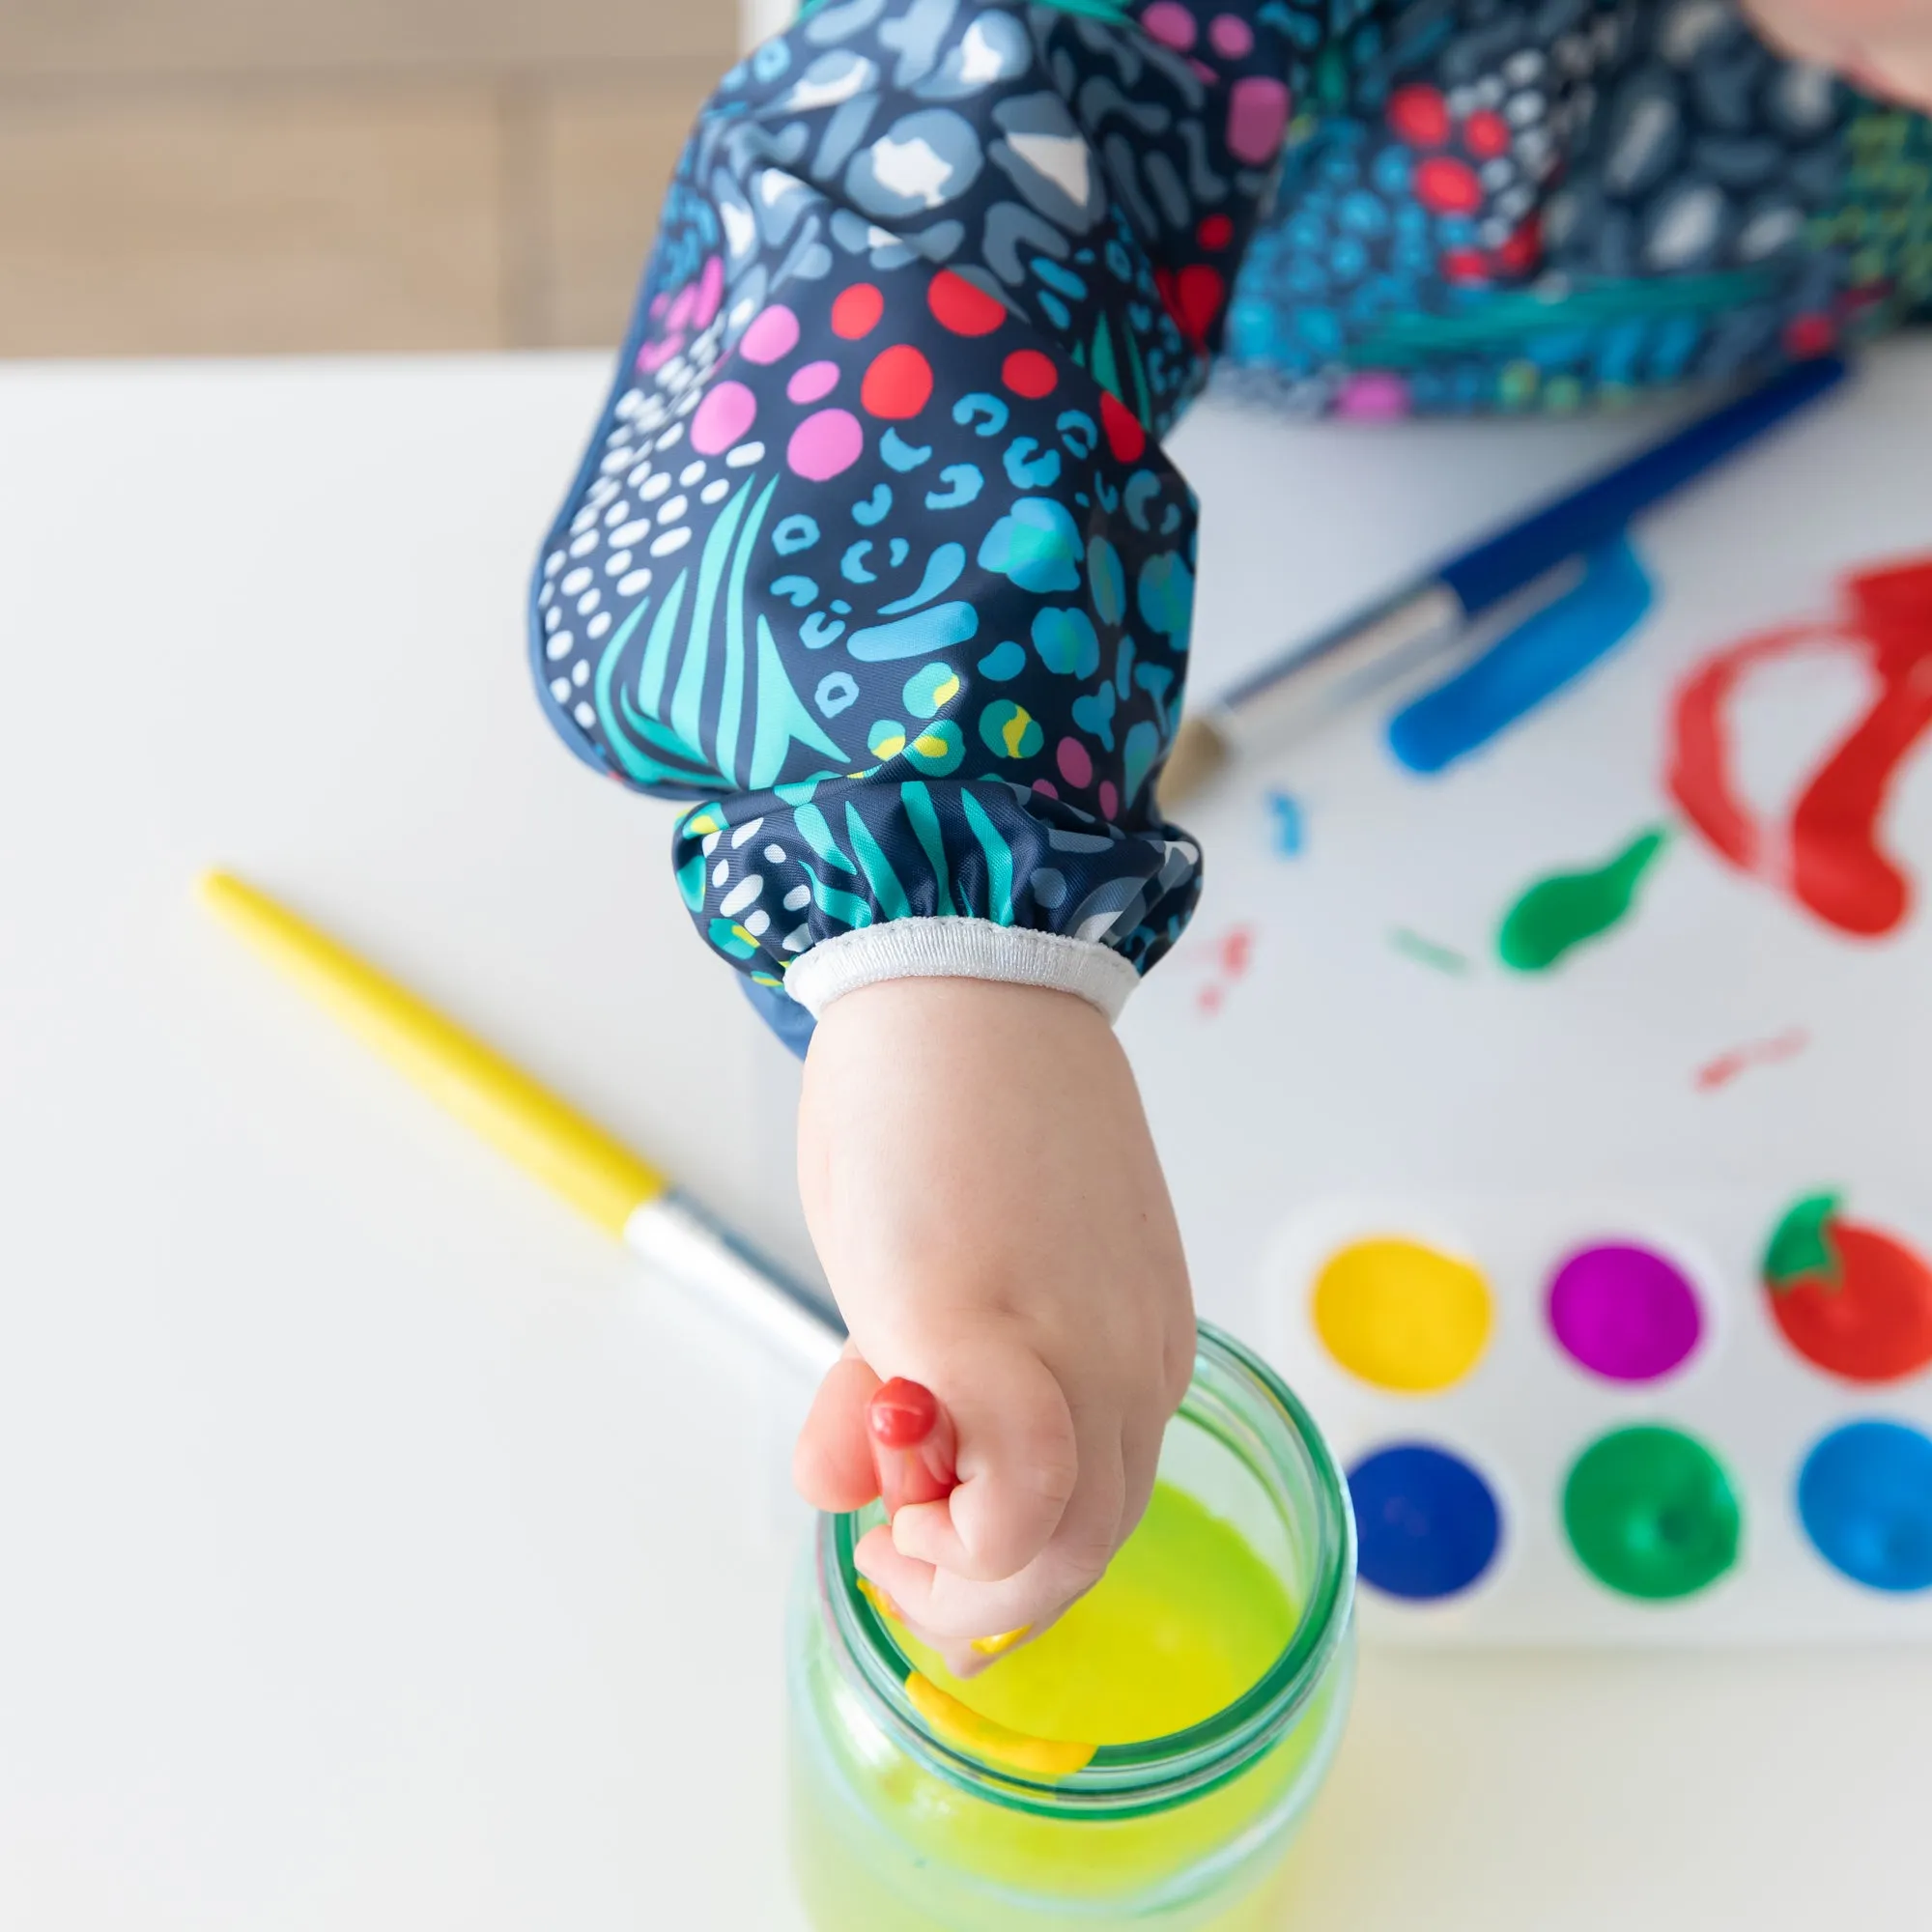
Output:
[{"left": 784, "top": 918, "right": 1140, "bottom": 1020}]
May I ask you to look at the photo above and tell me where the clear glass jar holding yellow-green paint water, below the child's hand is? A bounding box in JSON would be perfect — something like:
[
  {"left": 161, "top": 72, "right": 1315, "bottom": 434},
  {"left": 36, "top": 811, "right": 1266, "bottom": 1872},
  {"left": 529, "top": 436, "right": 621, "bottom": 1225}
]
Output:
[{"left": 788, "top": 1325, "right": 1354, "bottom": 1932}]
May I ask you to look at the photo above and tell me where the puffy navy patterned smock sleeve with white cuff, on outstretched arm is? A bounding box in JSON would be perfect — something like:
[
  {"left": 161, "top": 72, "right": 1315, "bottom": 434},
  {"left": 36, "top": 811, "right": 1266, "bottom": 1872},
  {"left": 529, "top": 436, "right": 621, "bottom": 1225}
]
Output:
[{"left": 531, "top": 0, "right": 1325, "bottom": 1043}]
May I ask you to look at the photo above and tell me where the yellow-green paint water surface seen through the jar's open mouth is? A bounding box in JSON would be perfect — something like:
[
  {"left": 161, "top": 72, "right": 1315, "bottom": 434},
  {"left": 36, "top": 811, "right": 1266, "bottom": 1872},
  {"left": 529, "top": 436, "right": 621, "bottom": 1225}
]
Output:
[{"left": 895, "top": 1482, "right": 1296, "bottom": 1768}]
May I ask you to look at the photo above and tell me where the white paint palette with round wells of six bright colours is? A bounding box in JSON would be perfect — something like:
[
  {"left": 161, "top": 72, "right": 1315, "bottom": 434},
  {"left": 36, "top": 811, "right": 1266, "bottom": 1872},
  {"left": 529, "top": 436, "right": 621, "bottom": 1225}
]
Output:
[{"left": 1264, "top": 1190, "right": 1932, "bottom": 1642}]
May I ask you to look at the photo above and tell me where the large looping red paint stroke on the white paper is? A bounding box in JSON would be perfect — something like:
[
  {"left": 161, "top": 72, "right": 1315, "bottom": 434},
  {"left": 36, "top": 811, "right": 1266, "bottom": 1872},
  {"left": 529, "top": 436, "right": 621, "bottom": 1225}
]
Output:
[{"left": 1667, "top": 556, "right": 1932, "bottom": 939}]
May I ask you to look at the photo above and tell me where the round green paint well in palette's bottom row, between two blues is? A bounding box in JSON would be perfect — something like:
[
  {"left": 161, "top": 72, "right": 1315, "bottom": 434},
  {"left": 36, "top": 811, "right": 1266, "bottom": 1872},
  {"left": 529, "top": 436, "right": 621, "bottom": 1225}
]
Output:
[{"left": 1563, "top": 1424, "right": 1743, "bottom": 1604}]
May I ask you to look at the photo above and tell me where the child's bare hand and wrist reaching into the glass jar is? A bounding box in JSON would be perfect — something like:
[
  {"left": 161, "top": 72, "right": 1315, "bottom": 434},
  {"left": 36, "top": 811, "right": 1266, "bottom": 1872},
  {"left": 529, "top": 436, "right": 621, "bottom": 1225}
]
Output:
[{"left": 794, "top": 980, "right": 1194, "bottom": 1669}]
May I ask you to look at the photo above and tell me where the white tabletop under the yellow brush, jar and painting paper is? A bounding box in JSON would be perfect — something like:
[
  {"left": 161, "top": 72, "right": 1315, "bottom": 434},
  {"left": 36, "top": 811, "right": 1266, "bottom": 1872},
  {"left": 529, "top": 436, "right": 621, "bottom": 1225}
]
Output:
[{"left": 0, "top": 357, "right": 1932, "bottom": 1932}]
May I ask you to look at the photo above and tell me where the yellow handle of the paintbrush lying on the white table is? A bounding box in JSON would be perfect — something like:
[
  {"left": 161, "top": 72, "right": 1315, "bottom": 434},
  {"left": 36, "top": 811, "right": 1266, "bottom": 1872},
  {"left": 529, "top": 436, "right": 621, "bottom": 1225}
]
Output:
[{"left": 201, "top": 871, "right": 670, "bottom": 1236}]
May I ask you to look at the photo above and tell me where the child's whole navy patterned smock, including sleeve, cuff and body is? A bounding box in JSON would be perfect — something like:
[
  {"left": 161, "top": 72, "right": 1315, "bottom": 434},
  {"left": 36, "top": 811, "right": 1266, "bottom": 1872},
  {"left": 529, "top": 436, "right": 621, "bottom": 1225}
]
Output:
[{"left": 531, "top": 0, "right": 1932, "bottom": 1043}]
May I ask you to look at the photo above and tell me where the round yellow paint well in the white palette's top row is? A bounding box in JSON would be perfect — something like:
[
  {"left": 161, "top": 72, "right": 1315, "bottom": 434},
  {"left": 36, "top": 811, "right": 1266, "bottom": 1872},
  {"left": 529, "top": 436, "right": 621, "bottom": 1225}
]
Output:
[{"left": 1314, "top": 1236, "right": 1493, "bottom": 1395}]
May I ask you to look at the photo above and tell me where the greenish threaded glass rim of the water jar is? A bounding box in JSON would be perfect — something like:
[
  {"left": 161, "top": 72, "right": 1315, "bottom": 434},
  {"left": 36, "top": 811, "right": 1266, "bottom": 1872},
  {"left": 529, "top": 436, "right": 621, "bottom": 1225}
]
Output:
[{"left": 817, "top": 1321, "right": 1354, "bottom": 1818}]
